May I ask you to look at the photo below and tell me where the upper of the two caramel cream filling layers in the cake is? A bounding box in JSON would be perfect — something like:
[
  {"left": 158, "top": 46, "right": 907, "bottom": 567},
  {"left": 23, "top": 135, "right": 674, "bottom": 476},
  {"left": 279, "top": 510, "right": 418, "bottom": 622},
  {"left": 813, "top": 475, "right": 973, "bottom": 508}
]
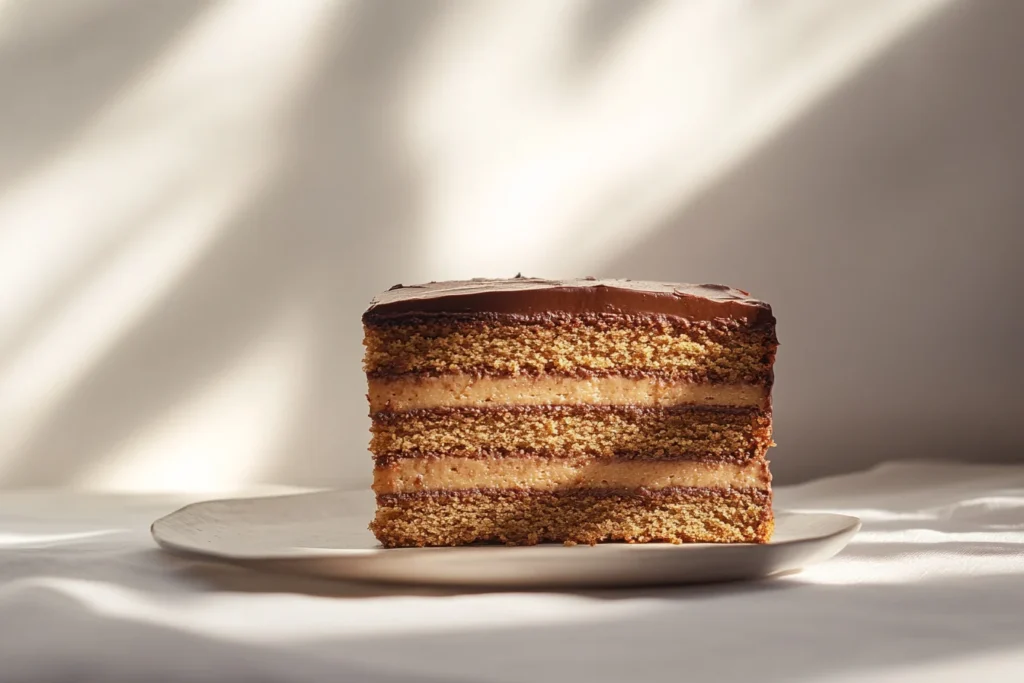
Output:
[{"left": 368, "top": 375, "right": 768, "bottom": 413}]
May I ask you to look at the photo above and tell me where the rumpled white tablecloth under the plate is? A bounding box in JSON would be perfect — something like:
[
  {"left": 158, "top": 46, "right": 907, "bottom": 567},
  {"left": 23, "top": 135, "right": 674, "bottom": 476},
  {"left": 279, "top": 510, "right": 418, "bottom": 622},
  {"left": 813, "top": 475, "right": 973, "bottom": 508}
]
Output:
[{"left": 0, "top": 463, "right": 1024, "bottom": 683}]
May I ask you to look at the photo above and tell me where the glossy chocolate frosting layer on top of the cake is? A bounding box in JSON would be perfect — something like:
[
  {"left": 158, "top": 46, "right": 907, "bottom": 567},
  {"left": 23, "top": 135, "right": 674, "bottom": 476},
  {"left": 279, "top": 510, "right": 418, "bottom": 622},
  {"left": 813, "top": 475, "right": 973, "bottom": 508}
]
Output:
[{"left": 362, "top": 276, "right": 775, "bottom": 327}]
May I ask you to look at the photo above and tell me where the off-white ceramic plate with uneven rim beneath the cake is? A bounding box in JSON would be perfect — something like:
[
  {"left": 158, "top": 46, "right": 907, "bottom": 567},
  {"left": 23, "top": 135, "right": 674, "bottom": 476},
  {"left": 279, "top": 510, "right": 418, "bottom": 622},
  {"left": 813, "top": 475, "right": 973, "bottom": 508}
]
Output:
[{"left": 153, "top": 492, "right": 860, "bottom": 588}]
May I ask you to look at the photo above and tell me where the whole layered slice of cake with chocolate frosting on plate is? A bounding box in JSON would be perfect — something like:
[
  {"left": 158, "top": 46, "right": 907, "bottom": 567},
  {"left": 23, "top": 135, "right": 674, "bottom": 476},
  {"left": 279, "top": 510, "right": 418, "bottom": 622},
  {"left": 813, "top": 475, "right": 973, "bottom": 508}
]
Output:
[{"left": 362, "top": 278, "right": 778, "bottom": 548}]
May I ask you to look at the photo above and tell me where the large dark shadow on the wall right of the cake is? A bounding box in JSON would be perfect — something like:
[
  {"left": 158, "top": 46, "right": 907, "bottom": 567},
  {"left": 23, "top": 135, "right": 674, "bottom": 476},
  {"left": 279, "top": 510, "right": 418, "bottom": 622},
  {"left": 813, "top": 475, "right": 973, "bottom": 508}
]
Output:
[{"left": 599, "top": 2, "right": 1024, "bottom": 483}]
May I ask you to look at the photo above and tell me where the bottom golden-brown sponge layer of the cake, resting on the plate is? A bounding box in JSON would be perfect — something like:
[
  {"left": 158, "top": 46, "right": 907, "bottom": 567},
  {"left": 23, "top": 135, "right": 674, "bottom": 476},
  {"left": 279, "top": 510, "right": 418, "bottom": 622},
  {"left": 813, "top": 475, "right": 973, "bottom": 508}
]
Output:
[{"left": 370, "top": 488, "right": 774, "bottom": 548}]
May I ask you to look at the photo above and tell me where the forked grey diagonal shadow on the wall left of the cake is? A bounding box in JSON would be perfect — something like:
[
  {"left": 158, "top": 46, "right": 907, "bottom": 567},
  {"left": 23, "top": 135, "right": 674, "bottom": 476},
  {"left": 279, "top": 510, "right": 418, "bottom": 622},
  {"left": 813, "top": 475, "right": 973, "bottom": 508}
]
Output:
[{"left": 1, "top": 2, "right": 438, "bottom": 485}]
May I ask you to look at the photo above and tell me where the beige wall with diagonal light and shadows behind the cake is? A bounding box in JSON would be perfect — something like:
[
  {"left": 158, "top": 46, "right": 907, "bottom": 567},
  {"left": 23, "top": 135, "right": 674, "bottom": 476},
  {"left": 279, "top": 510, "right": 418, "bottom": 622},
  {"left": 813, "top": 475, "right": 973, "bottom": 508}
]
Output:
[{"left": 0, "top": 0, "right": 1024, "bottom": 489}]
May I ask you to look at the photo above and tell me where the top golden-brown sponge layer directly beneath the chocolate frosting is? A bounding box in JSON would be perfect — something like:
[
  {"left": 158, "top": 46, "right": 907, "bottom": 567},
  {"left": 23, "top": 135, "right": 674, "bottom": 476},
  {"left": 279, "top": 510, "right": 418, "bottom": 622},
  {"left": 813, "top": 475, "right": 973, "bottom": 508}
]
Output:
[{"left": 364, "top": 314, "right": 777, "bottom": 384}]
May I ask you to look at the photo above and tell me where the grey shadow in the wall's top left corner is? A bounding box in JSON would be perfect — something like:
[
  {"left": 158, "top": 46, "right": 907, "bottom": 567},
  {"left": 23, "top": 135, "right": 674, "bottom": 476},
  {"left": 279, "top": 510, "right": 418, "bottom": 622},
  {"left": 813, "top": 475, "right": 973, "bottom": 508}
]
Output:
[{"left": 0, "top": 0, "right": 209, "bottom": 188}]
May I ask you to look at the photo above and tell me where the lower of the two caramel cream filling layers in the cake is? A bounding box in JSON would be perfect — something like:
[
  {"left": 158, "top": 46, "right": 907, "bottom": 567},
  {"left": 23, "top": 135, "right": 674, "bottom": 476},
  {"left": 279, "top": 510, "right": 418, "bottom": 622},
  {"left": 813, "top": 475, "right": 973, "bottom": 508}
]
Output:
[{"left": 374, "top": 457, "right": 771, "bottom": 494}]
